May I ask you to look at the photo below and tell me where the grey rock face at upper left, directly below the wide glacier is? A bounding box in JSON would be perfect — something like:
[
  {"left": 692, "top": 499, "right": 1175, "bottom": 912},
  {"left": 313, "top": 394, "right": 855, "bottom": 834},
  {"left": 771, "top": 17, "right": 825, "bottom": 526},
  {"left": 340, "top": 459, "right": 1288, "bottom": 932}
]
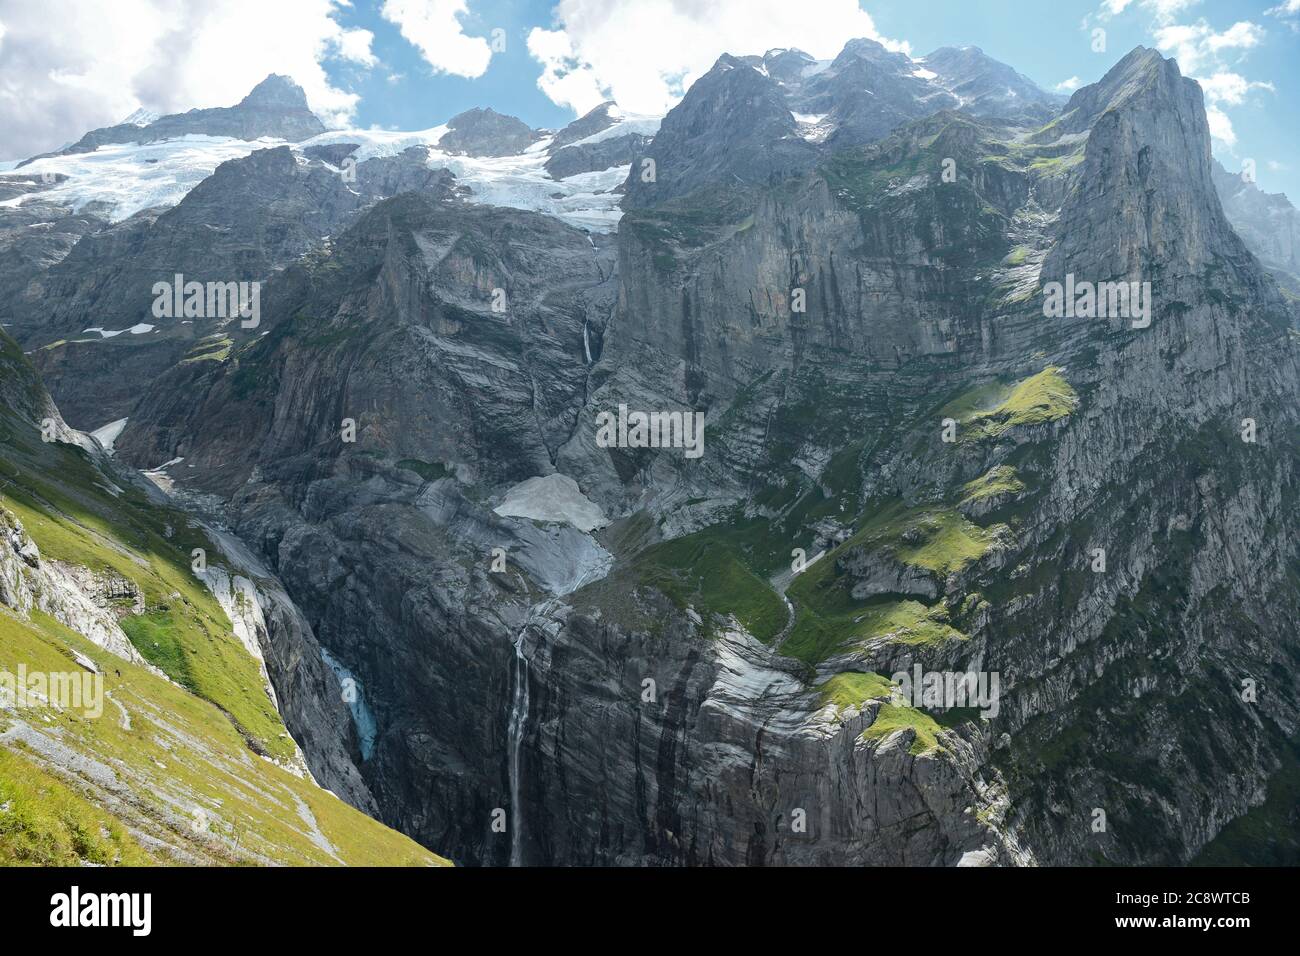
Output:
[{"left": 10, "top": 147, "right": 452, "bottom": 429}]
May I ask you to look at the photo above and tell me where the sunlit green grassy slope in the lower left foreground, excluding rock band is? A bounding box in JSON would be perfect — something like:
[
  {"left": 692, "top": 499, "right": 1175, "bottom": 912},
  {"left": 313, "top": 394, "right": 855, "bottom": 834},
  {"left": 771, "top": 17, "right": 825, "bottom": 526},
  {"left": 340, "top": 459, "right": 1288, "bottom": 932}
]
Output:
[{"left": 0, "top": 332, "right": 447, "bottom": 865}]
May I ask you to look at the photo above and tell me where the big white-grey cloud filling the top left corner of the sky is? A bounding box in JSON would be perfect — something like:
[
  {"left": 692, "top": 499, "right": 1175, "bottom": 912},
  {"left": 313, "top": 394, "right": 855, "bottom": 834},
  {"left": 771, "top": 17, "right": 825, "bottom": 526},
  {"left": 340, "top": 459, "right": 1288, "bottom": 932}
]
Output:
[{"left": 0, "top": 0, "right": 374, "bottom": 159}]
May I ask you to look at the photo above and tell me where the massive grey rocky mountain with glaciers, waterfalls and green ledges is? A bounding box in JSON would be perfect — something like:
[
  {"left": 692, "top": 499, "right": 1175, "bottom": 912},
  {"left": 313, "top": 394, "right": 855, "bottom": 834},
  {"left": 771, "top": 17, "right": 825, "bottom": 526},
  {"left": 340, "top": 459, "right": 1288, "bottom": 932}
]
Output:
[{"left": 0, "top": 40, "right": 1300, "bottom": 866}]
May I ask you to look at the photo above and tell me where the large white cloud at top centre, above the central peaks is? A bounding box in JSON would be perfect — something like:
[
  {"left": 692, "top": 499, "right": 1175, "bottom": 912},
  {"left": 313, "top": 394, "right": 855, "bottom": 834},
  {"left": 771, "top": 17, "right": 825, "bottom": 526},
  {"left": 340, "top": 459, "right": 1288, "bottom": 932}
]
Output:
[{"left": 528, "top": 0, "right": 909, "bottom": 113}]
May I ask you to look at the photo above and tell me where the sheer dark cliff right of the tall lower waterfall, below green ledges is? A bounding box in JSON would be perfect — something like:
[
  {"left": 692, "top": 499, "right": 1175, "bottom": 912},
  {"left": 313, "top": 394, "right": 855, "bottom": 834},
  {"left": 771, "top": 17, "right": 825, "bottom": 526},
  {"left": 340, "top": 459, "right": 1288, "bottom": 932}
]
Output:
[{"left": 516, "top": 609, "right": 1026, "bottom": 866}]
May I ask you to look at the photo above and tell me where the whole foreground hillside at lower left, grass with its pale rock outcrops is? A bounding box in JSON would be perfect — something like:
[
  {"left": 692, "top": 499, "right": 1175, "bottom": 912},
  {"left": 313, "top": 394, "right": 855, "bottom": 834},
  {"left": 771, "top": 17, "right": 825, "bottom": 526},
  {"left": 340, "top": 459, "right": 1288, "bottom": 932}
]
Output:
[{"left": 0, "top": 325, "right": 446, "bottom": 866}]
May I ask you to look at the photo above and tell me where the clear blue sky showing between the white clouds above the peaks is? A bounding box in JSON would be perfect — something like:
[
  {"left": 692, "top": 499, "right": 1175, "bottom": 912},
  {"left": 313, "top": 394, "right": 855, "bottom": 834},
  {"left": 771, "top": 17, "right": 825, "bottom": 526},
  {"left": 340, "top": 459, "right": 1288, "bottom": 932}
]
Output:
[{"left": 314, "top": 0, "right": 1300, "bottom": 203}]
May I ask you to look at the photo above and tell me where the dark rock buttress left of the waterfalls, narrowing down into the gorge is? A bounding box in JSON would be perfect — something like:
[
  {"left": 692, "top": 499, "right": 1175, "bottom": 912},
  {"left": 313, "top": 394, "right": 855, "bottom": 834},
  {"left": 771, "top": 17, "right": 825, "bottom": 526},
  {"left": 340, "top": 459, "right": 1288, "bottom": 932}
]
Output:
[{"left": 107, "top": 194, "right": 612, "bottom": 856}]
